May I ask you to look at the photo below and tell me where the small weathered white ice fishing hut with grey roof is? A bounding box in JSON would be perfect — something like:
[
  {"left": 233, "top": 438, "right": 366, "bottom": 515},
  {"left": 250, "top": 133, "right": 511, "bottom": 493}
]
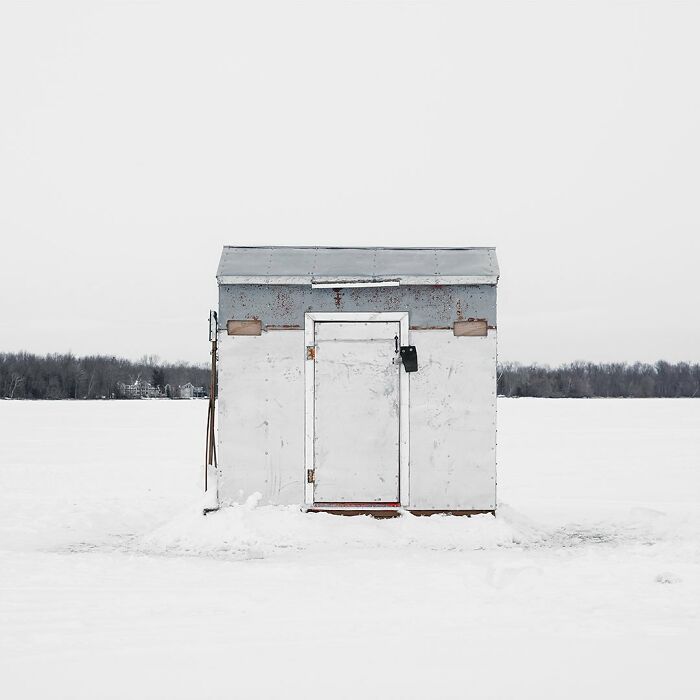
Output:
[{"left": 216, "top": 247, "right": 498, "bottom": 514}]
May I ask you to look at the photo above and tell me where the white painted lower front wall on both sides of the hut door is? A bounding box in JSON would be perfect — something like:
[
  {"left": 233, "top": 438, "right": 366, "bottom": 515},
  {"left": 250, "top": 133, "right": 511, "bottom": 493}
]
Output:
[{"left": 218, "top": 330, "right": 496, "bottom": 510}]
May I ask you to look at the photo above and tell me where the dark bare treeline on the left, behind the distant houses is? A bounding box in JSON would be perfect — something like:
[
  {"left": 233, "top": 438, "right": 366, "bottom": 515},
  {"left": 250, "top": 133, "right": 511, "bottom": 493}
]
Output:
[{"left": 0, "top": 352, "right": 209, "bottom": 399}]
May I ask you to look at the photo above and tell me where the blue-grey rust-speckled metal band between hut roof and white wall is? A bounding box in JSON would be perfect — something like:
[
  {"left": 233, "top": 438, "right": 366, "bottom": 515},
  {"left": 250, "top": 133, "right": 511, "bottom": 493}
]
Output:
[{"left": 219, "top": 284, "right": 496, "bottom": 330}]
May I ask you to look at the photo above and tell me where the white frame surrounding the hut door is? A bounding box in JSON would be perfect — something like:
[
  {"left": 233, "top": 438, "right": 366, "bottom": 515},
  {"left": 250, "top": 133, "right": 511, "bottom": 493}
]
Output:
[{"left": 303, "top": 311, "right": 410, "bottom": 510}]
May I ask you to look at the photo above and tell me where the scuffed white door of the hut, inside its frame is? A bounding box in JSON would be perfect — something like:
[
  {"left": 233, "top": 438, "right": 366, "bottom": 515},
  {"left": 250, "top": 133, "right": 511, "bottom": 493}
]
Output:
[{"left": 313, "top": 321, "right": 400, "bottom": 504}]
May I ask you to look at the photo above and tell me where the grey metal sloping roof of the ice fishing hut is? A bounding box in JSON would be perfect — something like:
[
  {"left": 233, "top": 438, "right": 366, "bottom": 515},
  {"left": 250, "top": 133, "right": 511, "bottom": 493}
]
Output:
[{"left": 216, "top": 246, "right": 499, "bottom": 286}]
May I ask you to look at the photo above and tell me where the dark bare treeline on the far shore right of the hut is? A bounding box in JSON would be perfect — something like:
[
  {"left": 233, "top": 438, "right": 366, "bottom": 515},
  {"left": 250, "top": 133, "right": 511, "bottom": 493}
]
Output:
[{"left": 498, "top": 362, "right": 700, "bottom": 398}]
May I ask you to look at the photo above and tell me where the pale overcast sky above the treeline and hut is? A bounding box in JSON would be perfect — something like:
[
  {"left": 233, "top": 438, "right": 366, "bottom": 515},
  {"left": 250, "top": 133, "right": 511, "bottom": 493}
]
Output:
[{"left": 0, "top": 0, "right": 700, "bottom": 363}]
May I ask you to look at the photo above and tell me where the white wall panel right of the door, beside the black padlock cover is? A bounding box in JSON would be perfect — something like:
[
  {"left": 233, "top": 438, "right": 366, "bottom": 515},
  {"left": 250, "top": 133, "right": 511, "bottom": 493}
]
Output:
[{"left": 410, "top": 330, "right": 496, "bottom": 510}]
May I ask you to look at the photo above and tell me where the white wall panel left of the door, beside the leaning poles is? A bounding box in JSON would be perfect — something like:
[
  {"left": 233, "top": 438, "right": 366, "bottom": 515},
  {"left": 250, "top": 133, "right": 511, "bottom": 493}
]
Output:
[{"left": 217, "top": 331, "right": 304, "bottom": 505}]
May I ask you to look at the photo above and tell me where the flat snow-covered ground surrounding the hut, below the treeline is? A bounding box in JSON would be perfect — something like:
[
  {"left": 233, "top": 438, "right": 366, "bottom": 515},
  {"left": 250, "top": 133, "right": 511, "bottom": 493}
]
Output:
[{"left": 0, "top": 399, "right": 700, "bottom": 700}]
